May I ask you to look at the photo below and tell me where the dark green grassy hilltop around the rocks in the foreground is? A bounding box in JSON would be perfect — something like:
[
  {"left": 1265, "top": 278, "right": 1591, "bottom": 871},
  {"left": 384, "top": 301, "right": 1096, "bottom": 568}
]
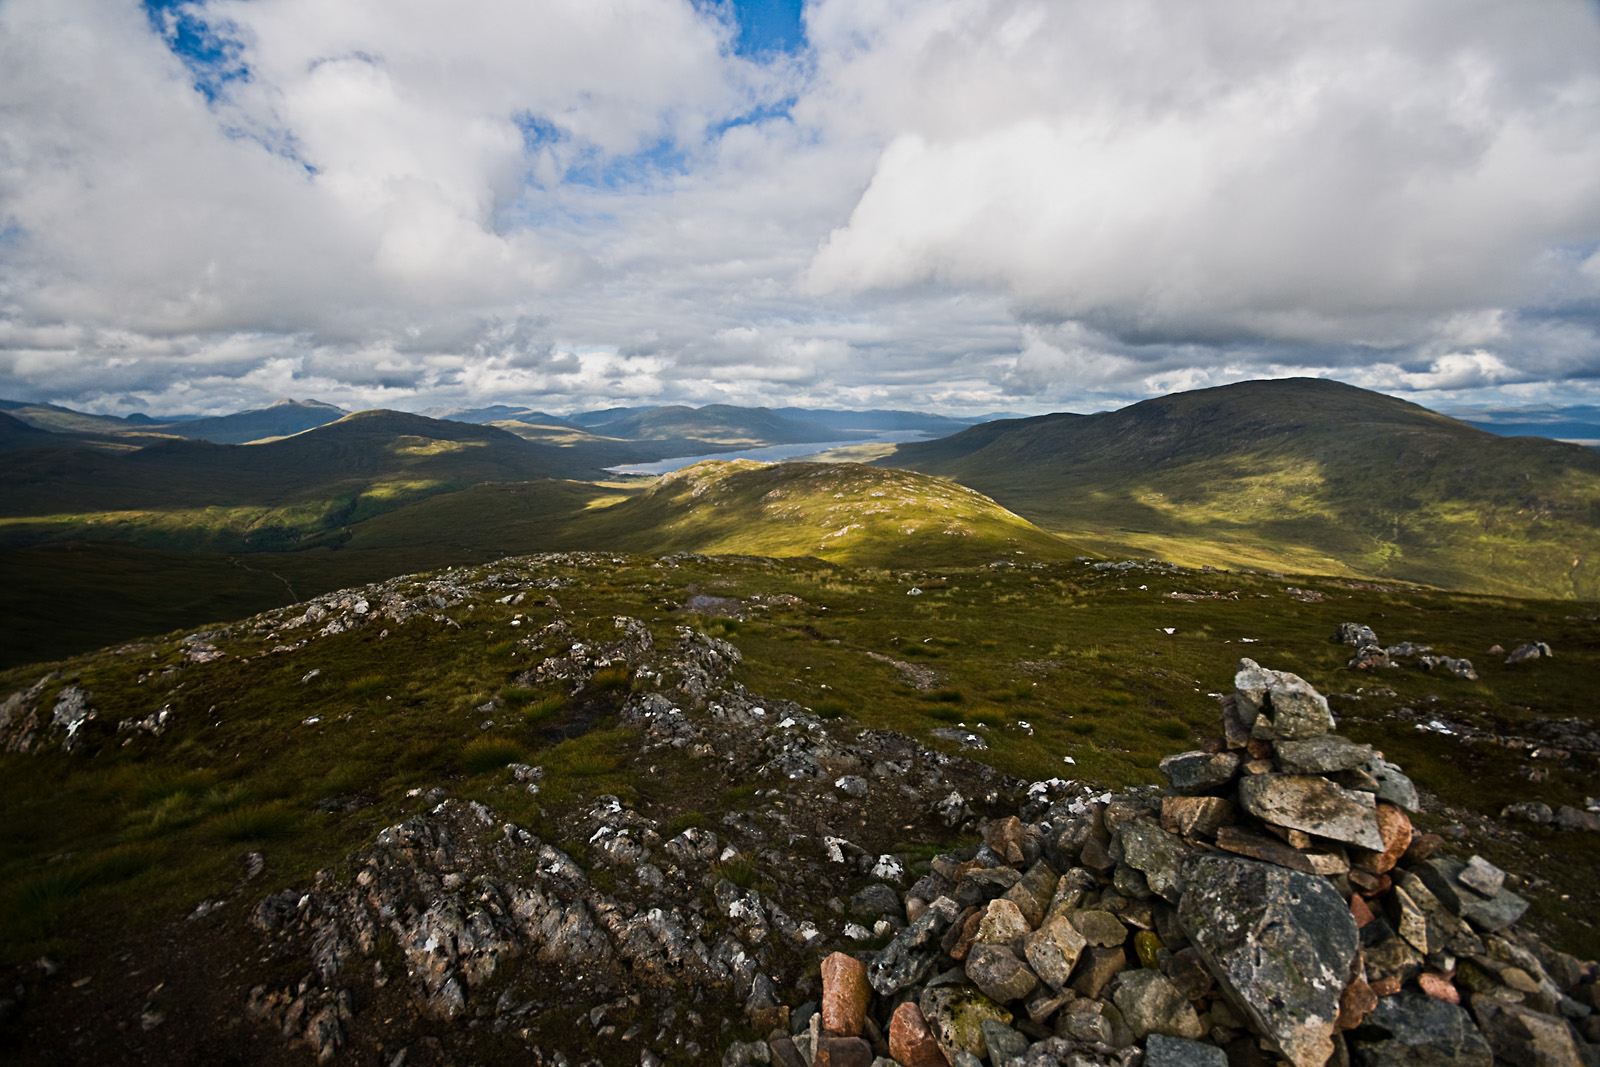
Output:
[{"left": 0, "top": 557, "right": 1600, "bottom": 961}]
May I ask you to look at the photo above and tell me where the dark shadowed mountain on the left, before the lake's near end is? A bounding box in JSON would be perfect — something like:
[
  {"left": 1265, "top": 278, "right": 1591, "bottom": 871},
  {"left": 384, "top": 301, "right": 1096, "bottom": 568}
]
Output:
[{"left": 0, "top": 411, "right": 603, "bottom": 550}]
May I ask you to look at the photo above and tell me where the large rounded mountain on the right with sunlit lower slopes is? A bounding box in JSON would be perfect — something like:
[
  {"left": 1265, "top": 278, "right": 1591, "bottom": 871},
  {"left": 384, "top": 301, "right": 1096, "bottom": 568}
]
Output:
[{"left": 880, "top": 379, "right": 1600, "bottom": 600}]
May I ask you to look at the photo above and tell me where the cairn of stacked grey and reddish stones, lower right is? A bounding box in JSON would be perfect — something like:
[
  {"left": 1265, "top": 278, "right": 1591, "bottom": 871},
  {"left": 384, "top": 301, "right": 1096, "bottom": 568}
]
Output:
[{"left": 784, "top": 659, "right": 1600, "bottom": 1067}]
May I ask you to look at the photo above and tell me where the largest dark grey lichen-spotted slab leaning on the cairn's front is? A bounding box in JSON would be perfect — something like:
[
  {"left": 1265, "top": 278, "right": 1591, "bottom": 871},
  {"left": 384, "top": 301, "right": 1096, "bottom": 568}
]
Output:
[{"left": 1178, "top": 856, "right": 1360, "bottom": 1067}]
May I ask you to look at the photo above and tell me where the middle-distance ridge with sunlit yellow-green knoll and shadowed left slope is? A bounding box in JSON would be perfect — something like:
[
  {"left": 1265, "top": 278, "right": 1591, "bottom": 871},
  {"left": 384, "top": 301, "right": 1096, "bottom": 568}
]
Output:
[{"left": 0, "top": 462, "right": 1078, "bottom": 665}]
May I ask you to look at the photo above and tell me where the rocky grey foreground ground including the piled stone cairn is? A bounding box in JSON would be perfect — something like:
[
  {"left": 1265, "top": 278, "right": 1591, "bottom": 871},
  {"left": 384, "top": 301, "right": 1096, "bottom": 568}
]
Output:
[{"left": 3, "top": 563, "right": 1600, "bottom": 1067}]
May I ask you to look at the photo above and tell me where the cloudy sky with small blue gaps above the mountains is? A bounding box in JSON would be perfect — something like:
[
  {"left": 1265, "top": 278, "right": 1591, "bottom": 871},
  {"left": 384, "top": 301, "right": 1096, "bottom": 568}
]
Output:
[{"left": 0, "top": 0, "right": 1600, "bottom": 414}]
